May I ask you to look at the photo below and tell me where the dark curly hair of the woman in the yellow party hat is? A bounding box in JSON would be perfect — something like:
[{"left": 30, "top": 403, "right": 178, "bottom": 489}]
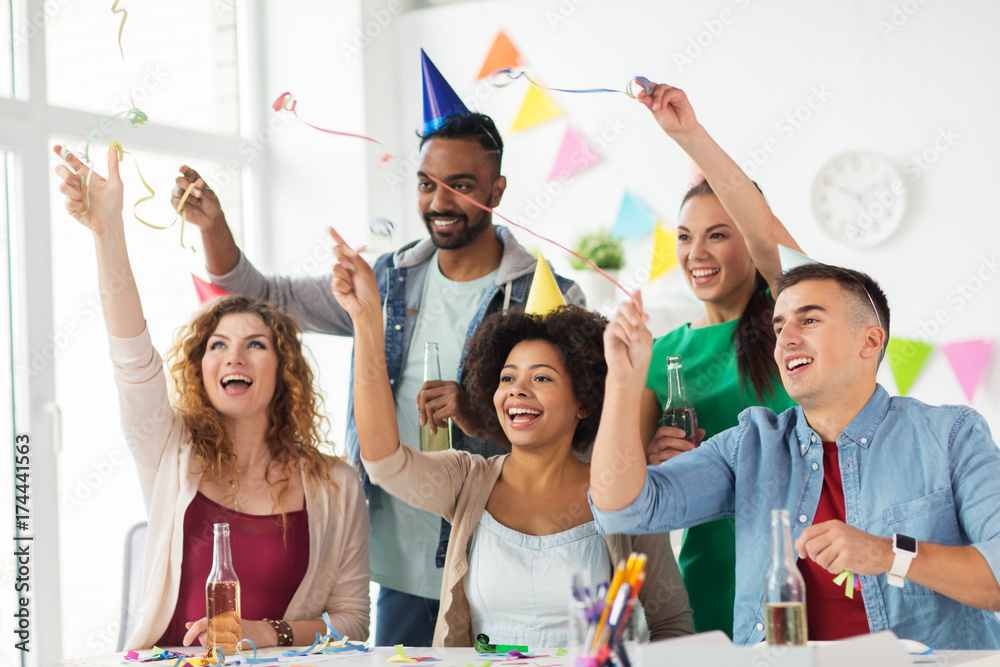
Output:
[{"left": 462, "top": 306, "right": 608, "bottom": 451}]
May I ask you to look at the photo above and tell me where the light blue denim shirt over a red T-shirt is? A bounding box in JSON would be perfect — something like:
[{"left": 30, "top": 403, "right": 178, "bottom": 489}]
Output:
[{"left": 594, "top": 386, "right": 1000, "bottom": 650}]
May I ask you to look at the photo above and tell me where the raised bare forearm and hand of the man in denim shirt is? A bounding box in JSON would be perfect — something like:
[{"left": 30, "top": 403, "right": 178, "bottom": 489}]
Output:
[{"left": 590, "top": 291, "right": 653, "bottom": 512}]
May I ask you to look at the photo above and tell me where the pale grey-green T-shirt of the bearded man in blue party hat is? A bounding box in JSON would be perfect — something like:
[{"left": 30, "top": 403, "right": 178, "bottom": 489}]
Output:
[{"left": 368, "top": 251, "right": 496, "bottom": 600}]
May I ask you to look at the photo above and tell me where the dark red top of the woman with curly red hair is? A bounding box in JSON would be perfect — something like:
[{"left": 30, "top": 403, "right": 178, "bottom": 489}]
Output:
[{"left": 157, "top": 491, "right": 309, "bottom": 646}]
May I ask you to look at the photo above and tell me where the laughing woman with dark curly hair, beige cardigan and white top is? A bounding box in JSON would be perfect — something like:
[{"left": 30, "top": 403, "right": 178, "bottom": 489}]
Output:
[{"left": 332, "top": 233, "right": 693, "bottom": 646}]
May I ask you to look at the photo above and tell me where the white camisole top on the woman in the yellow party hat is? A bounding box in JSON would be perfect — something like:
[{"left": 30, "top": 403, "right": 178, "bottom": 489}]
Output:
[{"left": 465, "top": 511, "right": 611, "bottom": 648}]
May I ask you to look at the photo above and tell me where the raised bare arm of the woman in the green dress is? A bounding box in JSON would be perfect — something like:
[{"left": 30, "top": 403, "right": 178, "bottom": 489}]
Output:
[{"left": 638, "top": 83, "right": 801, "bottom": 287}]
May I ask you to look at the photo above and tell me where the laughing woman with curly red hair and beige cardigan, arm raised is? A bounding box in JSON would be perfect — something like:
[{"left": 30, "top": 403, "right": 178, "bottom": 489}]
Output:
[{"left": 55, "top": 146, "right": 369, "bottom": 648}]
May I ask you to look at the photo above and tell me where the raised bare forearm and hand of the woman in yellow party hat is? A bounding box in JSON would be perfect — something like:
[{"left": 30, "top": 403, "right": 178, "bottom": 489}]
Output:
[{"left": 330, "top": 229, "right": 400, "bottom": 461}]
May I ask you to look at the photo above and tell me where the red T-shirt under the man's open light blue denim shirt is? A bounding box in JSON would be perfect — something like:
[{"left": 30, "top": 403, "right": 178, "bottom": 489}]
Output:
[{"left": 799, "top": 442, "right": 870, "bottom": 641}]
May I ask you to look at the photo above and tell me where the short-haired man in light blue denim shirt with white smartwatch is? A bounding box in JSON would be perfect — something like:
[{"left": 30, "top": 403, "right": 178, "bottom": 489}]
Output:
[{"left": 590, "top": 264, "right": 1000, "bottom": 649}]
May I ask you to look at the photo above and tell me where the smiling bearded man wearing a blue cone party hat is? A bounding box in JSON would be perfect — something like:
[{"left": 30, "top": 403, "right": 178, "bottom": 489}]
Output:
[{"left": 174, "top": 50, "right": 584, "bottom": 646}]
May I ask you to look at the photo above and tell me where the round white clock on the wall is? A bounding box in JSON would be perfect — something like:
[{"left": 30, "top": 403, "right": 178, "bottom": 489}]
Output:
[{"left": 812, "top": 151, "right": 907, "bottom": 246}]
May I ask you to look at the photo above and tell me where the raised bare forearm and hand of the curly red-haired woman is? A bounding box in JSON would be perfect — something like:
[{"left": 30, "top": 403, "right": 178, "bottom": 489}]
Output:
[{"left": 52, "top": 146, "right": 146, "bottom": 338}]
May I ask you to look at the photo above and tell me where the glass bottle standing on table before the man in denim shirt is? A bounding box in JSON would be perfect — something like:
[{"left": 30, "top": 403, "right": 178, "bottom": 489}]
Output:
[{"left": 764, "top": 510, "right": 809, "bottom": 646}]
